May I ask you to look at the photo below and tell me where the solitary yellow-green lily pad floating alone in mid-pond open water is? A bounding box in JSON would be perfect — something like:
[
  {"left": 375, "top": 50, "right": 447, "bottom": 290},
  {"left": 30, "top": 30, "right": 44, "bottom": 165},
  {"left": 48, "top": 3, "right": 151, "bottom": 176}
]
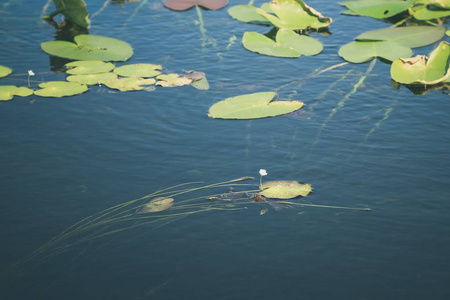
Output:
[{"left": 208, "top": 92, "right": 303, "bottom": 119}]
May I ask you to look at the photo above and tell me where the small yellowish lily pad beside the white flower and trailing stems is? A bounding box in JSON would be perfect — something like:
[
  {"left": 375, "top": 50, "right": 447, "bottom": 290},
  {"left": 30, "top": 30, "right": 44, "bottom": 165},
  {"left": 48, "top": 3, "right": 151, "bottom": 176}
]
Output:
[{"left": 259, "top": 181, "right": 312, "bottom": 199}]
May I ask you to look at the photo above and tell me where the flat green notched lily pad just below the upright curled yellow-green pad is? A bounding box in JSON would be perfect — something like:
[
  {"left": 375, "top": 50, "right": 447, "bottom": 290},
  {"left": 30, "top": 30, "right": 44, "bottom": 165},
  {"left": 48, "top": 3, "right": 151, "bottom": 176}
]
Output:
[{"left": 242, "top": 29, "right": 323, "bottom": 58}]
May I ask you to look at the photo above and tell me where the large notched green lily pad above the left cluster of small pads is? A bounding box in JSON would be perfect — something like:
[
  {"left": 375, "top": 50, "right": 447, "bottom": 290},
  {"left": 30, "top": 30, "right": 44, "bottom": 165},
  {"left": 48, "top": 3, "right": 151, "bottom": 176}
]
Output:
[{"left": 41, "top": 34, "right": 133, "bottom": 61}]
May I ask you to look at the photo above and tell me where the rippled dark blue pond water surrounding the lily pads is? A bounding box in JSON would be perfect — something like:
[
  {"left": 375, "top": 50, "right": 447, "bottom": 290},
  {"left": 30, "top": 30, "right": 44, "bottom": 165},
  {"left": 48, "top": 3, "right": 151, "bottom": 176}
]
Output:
[{"left": 0, "top": 0, "right": 450, "bottom": 300}]
